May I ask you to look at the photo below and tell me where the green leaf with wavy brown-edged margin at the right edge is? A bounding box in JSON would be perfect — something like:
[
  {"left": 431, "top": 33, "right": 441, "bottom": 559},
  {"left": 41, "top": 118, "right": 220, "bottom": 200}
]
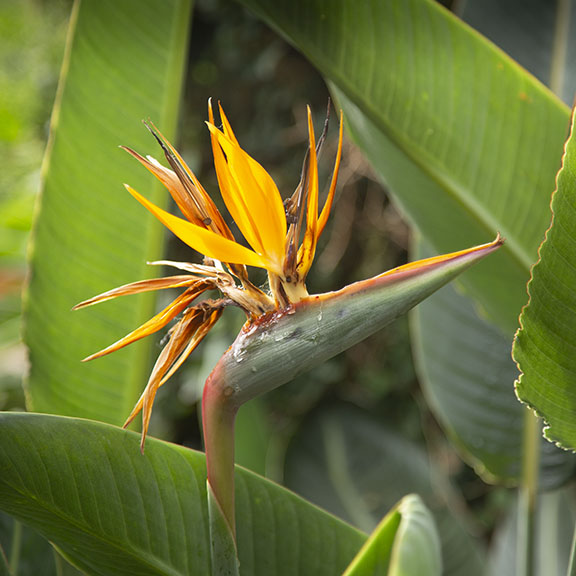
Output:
[{"left": 514, "top": 109, "right": 576, "bottom": 450}]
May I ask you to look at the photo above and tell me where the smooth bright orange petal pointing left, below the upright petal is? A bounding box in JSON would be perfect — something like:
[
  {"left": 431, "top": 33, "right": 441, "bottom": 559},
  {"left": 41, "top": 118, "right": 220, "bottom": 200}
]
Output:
[{"left": 125, "top": 184, "right": 267, "bottom": 268}]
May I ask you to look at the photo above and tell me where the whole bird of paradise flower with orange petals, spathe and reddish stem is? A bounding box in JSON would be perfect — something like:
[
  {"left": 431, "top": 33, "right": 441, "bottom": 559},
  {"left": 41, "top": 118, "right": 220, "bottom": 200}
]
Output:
[{"left": 76, "top": 102, "right": 503, "bottom": 574}]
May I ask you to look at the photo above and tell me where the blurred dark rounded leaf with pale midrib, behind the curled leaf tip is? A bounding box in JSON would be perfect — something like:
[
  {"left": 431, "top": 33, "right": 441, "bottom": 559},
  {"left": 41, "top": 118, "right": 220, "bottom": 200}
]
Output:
[{"left": 284, "top": 405, "right": 484, "bottom": 576}]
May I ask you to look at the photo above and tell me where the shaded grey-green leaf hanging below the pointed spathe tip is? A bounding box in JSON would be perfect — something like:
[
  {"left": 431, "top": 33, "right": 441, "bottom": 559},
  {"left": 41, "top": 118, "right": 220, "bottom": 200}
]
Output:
[{"left": 411, "top": 236, "right": 576, "bottom": 489}]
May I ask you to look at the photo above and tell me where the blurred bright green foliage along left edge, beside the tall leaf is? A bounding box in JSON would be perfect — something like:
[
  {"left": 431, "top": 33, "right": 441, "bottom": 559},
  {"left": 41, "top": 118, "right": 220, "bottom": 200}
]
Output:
[{"left": 0, "top": 0, "right": 72, "bottom": 409}]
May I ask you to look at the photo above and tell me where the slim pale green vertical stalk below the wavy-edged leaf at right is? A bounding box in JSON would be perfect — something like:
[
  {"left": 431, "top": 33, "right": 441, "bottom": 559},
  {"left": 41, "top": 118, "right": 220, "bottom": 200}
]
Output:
[{"left": 516, "top": 408, "right": 542, "bottom": 576}]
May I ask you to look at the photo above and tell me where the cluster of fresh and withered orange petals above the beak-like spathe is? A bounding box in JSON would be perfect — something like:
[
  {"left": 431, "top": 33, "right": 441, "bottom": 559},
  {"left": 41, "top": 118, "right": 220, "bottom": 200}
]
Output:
[{"left": 75, "top": 102, "right": 342, "bottom": 447}]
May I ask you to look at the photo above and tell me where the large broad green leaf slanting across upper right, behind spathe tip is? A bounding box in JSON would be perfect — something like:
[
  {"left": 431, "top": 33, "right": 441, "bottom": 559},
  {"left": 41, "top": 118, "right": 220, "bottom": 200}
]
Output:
[{"left": 242, "top": 0, "right": 568, "bottom": 335}]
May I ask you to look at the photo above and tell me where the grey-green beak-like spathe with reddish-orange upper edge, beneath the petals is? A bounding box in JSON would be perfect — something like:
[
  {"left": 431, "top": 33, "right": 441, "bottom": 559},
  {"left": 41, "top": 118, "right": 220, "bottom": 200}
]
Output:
[{"left": 207, "top": 237, "right": 503, "bottom": 406}]
